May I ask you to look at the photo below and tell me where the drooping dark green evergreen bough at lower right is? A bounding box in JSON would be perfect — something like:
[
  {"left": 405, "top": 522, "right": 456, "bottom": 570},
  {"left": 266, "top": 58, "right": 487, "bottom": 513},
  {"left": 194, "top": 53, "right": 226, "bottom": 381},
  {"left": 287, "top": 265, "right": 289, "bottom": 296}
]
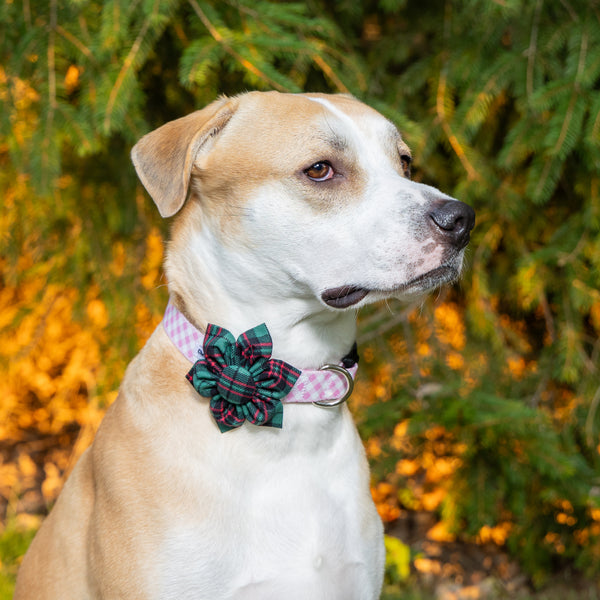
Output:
[{"left": 414, "top": 390, "right": 594, "bottom": 582}]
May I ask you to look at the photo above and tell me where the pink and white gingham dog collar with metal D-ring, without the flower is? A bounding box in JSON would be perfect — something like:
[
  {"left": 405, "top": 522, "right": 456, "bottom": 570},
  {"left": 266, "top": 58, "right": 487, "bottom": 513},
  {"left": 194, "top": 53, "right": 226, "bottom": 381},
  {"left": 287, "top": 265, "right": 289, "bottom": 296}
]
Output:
[{"left": 162, "top": 299, "right": 358, "bottom": 406}]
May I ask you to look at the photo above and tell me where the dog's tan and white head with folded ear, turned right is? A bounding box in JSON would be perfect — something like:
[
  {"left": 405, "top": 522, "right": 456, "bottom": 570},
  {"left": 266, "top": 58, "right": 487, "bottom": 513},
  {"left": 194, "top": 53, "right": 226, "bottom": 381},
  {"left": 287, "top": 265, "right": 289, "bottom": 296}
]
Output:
[{"left": 132, "top": 92, "right": 475, "bottom": 311}]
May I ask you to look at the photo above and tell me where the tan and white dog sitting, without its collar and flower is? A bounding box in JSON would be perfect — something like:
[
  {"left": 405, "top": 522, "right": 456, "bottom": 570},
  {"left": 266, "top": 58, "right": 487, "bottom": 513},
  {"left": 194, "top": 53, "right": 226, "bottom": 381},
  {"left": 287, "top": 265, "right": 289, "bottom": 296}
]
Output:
[{"left": 15, "top": 92, "right": 474, "bottom": 600}]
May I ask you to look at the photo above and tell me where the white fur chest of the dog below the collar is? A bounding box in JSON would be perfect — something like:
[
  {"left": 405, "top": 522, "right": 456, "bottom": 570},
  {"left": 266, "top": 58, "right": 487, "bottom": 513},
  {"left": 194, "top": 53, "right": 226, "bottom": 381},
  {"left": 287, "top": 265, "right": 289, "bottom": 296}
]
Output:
[{"left": 152, "top": 406, "right": 381, "bottom": 600}]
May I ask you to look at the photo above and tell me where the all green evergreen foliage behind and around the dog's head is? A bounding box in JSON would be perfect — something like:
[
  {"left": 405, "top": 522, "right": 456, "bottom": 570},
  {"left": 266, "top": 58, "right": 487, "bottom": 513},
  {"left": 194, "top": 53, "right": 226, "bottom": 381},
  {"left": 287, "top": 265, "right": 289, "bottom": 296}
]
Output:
[{"left": 0, "top": 0, "right": 600, "bottom": 580}]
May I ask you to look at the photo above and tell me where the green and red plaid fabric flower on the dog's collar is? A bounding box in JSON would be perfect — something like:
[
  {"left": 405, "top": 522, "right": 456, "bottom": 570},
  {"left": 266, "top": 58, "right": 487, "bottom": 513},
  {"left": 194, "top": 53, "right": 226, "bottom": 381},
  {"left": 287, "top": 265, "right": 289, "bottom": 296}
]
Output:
[{"left": 186, "top": 323, "right": 301, "bottom": 432}]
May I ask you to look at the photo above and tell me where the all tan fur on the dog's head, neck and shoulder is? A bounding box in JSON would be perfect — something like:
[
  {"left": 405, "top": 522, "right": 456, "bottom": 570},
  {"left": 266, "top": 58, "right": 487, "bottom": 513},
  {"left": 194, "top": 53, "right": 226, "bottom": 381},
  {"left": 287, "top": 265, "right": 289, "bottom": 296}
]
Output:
[{"left": 15, "top": 93, "right": 390, "bottom": 600}]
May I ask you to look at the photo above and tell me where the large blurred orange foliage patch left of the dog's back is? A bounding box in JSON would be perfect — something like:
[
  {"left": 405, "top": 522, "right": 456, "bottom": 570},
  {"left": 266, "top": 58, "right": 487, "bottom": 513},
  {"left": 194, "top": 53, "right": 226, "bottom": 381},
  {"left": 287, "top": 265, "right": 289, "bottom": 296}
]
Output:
[{"left": 0, "top": 278, "right": 110, "bottom": 508}]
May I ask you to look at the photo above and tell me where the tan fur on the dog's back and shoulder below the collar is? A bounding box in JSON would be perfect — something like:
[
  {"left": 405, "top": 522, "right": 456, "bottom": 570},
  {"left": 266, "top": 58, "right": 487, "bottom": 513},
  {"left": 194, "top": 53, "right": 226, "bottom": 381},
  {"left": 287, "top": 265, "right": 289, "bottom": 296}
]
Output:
[{"left": 15, "top": 329, "right": 193, "bottom": 600}]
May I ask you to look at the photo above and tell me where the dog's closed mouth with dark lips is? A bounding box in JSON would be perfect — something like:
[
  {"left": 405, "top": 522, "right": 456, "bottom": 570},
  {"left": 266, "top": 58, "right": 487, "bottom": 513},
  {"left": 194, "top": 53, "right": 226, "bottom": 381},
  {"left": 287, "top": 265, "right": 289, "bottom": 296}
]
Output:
[{"left": 321, "top": 265, "right": 460, "bottom": 308}]
